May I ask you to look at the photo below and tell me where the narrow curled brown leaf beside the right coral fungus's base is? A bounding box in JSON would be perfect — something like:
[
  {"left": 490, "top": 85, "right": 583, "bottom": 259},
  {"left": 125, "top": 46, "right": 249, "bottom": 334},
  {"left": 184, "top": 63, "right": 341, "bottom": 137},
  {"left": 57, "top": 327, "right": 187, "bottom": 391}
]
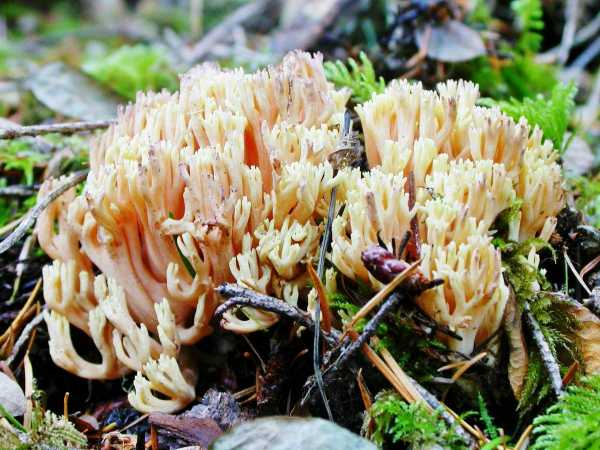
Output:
[{"left": 504, "top": 289, "right": 529, "bottom": 400}]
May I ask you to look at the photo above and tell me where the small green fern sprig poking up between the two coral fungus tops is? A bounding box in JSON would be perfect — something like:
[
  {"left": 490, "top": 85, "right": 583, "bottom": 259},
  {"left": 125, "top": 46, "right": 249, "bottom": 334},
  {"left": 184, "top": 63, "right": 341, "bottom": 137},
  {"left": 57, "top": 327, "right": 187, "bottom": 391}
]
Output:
[{"left": 325, "top": 52, "right": 385, "bottom": 104}]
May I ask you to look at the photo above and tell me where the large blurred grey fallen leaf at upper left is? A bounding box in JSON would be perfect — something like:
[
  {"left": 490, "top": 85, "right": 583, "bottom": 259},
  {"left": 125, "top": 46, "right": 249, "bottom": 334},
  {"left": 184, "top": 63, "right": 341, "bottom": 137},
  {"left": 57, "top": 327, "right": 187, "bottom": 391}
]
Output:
[{"left": 25, "top": 63, "right": 120, "bottom": 120}]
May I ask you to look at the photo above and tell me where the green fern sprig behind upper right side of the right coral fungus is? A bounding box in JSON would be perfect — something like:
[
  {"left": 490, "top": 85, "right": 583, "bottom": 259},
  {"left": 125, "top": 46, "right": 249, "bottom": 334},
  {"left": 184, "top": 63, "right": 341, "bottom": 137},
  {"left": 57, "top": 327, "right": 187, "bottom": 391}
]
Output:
[{"left": 497, "top": 83, "right": 577, "bottom": 152}]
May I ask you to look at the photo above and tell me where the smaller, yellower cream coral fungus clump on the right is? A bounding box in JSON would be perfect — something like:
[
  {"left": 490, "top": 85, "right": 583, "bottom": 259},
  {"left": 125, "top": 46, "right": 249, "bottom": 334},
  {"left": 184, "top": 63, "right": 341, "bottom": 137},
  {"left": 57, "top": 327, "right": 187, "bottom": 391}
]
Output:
[{"left": 331, "top": 81, "right": 564, "bottom": 354}]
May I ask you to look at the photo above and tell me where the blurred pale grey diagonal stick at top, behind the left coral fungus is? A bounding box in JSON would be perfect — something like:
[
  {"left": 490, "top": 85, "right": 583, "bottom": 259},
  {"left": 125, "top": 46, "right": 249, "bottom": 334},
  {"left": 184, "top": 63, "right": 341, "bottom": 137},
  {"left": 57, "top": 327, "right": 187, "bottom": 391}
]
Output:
[{"left": 187, "top": 0, "right": 271, "bottom": 63}]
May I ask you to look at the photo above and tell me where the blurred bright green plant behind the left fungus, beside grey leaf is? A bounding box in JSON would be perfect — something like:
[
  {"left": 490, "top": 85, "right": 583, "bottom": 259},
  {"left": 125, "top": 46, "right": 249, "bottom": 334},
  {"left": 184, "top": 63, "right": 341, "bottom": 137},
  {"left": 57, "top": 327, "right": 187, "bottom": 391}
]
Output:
[{"left": 83, "top": 44, "right": 177, "bottom": 100}]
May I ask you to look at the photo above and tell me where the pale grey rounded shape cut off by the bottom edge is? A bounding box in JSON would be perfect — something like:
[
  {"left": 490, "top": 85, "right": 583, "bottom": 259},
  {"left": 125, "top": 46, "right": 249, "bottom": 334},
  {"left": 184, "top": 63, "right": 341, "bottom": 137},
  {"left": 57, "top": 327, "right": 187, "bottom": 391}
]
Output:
[{"left": 209, "top": 416, "right": 377, "bottom": 450}]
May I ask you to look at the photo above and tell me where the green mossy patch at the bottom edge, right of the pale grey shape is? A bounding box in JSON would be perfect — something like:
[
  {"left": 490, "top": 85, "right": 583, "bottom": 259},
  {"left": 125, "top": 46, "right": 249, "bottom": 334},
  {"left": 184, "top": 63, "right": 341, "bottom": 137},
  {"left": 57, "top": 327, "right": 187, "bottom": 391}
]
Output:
[{"left": 371, "top": 392, "right": 467, "bottom": 449}]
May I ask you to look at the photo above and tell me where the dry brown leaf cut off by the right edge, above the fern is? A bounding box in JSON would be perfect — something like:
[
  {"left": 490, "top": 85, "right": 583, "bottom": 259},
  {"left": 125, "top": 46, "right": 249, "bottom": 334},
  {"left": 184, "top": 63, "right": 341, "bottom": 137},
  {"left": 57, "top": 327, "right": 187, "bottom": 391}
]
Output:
[{"left": 569, "top": 304, "right": 600, "bottom": 375}]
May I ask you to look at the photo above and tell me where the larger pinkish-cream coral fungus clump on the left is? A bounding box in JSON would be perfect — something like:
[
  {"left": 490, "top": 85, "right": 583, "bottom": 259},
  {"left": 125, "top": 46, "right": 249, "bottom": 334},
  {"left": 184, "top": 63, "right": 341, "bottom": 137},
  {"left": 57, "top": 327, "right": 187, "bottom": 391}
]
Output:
[{"left": 37, "top": 52, "right": 349, "bottom": 411}]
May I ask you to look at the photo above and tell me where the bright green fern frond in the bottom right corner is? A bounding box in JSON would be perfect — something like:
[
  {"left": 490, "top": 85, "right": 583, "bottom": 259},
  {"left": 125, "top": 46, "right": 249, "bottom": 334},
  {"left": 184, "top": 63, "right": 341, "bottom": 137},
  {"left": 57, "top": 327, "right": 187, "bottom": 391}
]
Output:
[{"left": 531, "top": 375, "right": 600, "bottom": 450}]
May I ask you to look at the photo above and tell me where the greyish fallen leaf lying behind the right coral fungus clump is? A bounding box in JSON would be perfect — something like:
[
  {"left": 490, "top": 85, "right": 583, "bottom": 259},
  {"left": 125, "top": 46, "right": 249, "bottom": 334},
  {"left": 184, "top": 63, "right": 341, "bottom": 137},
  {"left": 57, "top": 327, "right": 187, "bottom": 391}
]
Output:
[{"left": 416, "top": 20, "right": 486, "bottom": 62}]
